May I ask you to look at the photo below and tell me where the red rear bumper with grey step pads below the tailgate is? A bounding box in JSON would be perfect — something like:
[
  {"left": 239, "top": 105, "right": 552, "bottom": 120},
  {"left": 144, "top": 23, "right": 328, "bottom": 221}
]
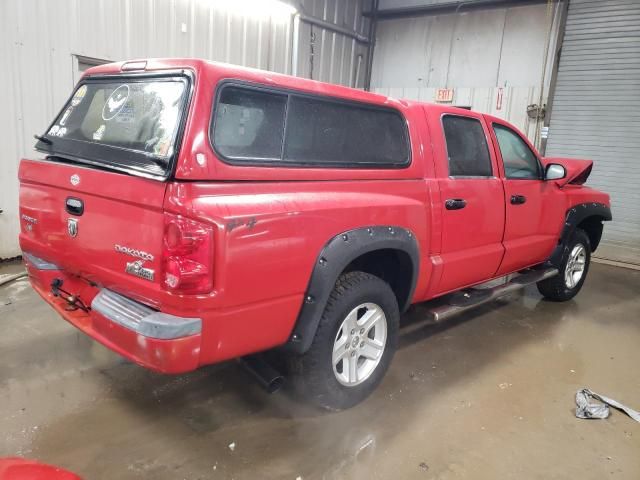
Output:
[{"left": 24, "top": 254, "right": 202, "bottom": 373}]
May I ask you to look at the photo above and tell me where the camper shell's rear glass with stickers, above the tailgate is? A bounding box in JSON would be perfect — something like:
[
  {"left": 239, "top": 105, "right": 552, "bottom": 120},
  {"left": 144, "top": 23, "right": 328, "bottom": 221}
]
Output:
[{"left": 36, "top": 77, "right": 188, "bottom": 176}]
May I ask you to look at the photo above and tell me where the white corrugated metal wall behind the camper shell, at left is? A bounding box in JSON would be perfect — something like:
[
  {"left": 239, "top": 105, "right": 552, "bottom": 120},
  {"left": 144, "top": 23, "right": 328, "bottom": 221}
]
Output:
[{"left": 0, "top": 0, "right": 368, "bottom": 258}]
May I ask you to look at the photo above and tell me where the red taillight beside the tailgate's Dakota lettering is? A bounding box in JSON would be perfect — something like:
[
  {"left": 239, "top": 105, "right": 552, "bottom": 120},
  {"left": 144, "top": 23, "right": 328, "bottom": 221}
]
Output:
[{"left": 162, "top": 213, "right": 213, "bottom": 294}]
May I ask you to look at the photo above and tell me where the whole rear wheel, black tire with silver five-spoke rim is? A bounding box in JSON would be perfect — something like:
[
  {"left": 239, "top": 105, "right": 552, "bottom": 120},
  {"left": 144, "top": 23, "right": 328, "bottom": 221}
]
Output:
[{"left": 295, "top": 272, "right": 400, "bottom": 410}]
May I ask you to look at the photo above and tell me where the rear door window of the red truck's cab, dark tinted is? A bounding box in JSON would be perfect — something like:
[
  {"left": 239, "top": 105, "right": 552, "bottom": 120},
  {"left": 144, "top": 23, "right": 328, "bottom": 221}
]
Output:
[{"left": 442, "top": 115, "right": 493, "bottom": 177}]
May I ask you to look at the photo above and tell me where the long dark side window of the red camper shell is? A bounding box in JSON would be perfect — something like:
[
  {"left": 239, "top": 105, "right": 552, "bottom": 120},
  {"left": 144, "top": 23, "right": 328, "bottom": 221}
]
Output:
[{"left": 210, "top": 81, "right": 410, "bottom": 168}]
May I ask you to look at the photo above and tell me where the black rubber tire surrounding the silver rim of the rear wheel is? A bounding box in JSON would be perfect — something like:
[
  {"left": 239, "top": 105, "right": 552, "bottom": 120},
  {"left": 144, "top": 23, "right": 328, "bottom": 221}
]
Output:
[{"left": 292, "top": 272, "right": 400, "bottom": 410}]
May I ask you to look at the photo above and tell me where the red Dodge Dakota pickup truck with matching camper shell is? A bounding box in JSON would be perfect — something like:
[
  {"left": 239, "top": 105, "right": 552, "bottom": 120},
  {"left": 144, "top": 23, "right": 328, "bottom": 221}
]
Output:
[{"left": 19, "top": 59, "right": 611, "bottom": 409}]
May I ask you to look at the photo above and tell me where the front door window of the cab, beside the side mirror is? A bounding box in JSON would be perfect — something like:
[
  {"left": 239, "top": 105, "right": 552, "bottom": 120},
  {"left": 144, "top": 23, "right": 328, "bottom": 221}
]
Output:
[{"left": 493, "top": 124, "right": 541, "bottom": 180}]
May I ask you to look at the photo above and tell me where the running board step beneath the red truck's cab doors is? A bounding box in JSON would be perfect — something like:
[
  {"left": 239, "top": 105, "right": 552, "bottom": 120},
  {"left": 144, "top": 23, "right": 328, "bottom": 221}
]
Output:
[{"left": 428, "top": 268, "right": 558, "bottom": 322}]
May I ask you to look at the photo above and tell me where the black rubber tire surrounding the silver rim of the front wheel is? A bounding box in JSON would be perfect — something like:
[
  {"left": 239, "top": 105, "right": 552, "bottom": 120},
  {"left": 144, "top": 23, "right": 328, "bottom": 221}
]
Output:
[{"left": 537, "top": 228, "right": 591, "bottom": 302}]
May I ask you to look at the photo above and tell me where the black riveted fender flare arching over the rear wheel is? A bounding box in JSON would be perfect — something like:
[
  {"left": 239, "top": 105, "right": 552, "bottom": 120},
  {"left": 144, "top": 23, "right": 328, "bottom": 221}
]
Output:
[{"left": 285, "top": 226, "right": 420, "bottom": 354}]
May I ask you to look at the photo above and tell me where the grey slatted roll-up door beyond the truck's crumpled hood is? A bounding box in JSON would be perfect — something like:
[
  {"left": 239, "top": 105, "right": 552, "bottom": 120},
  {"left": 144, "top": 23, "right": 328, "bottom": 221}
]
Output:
[{"left": 546, "top": 0, "right": 640, "bottom": 265}]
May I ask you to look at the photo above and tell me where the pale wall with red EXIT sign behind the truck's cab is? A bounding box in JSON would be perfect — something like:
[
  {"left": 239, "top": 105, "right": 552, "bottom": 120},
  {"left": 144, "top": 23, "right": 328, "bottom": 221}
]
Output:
[{"left": 371, "top": 2, "right": 560, "bottom": 141}]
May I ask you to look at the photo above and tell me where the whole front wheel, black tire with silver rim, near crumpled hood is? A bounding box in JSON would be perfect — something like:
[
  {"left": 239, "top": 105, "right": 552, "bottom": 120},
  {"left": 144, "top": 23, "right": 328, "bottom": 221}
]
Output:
[{"left": 537, "top": 228, "right": 591, "bottom": 302}]
